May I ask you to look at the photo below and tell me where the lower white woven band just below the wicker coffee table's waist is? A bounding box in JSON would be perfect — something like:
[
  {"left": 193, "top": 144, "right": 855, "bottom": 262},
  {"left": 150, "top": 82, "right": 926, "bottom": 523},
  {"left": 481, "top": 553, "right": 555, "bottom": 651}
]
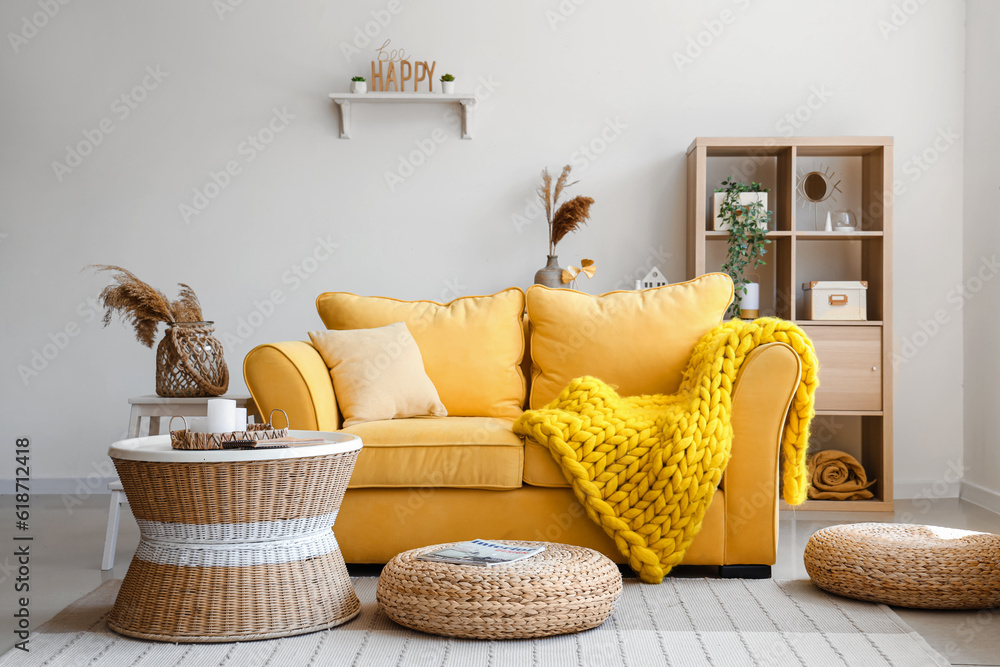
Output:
[{"left": 135, "top": 528, "right": 340, "bottom": 567}]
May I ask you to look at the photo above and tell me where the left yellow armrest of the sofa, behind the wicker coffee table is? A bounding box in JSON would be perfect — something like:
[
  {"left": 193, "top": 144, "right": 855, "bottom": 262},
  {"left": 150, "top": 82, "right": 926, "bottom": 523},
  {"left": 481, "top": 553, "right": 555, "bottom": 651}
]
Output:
[{"left": 243, "top": 341, "right": 340, "bottom": 431}]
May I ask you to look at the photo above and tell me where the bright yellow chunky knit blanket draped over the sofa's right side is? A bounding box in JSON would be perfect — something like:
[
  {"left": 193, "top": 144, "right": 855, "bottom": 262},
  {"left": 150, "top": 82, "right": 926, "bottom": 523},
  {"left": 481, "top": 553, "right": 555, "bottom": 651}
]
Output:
[{"left": 514, "top": 318, "right": 819, "bottom": 583}]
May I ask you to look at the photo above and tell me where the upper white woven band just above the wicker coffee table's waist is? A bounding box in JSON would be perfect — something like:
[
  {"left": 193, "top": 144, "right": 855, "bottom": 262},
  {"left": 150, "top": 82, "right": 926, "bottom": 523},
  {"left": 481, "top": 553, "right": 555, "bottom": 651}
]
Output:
[{"left": 136, "top": 512, "right": 337, "bottom": 543}]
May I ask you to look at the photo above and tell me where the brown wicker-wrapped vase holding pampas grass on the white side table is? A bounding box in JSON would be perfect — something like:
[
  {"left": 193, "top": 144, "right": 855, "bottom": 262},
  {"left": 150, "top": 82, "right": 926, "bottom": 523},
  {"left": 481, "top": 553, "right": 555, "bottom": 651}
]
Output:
[{"left": 156, "top": 322, "right": 229, "bottom": 398}]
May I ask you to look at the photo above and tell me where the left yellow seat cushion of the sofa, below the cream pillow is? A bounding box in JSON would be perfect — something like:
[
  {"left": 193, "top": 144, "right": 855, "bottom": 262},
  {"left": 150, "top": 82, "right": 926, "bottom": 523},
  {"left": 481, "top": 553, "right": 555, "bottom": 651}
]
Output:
[{"left": 344, "top": 417, "right": 524, "bottom": 489}]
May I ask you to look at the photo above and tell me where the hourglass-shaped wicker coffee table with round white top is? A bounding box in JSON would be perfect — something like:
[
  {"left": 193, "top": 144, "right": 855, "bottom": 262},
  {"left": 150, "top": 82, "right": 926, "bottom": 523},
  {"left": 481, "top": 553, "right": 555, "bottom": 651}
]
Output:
[{"left": 108, "top": 431, "right": 361, "bottom": 642}]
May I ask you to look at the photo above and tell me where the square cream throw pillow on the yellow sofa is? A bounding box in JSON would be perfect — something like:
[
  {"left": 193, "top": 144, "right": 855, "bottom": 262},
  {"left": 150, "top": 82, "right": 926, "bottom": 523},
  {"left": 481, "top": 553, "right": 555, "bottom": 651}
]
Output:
[{"left": 309, "top": 322, "right": 448, "bottom": 428}]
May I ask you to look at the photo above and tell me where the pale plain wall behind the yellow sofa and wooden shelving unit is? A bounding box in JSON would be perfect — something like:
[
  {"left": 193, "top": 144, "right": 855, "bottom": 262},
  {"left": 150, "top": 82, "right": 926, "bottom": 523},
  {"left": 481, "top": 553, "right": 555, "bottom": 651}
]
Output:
[{"left": 0, "top": 0, "right": 965, "bottom": 496}]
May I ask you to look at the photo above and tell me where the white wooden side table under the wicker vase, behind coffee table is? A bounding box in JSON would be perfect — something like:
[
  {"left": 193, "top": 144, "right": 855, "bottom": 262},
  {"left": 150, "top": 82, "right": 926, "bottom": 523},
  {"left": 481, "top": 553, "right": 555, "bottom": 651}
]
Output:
[{"left": 101, "top": 394, "right": 259, "bottom": 570}]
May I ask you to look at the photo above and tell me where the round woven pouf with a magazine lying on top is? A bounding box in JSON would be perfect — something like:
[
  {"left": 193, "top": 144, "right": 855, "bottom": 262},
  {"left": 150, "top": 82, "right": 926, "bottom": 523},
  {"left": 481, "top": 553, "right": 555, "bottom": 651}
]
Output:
[{"left": 377, "top": 542, "right": 622, "bottom": 639}]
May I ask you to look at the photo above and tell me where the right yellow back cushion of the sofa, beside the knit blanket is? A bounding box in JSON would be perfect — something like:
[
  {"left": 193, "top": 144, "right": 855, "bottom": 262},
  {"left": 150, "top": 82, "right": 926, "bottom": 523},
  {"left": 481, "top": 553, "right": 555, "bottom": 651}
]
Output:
[{"left": 528, "top": 273, "right": 733, "bottom": 409}]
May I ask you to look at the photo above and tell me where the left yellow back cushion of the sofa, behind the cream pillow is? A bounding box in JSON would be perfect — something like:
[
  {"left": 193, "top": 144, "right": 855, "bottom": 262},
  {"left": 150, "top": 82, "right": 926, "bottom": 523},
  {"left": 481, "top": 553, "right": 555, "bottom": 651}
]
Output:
[{"left": 316, "top": 287, "right": 526, "bottom": 419}]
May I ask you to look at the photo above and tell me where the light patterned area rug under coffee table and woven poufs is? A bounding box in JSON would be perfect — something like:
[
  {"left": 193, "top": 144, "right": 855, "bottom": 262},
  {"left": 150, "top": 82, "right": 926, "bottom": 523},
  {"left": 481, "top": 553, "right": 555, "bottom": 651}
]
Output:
[{"left": 0, "top": 577, "right": 948, "bottom": 667}]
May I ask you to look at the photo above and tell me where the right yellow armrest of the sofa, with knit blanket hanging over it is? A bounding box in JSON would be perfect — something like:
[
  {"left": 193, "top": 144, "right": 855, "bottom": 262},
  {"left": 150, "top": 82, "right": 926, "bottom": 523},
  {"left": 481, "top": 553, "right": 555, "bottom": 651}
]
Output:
[{"left": 723, "top": 343, "right": 802, "bottom": 565}]
